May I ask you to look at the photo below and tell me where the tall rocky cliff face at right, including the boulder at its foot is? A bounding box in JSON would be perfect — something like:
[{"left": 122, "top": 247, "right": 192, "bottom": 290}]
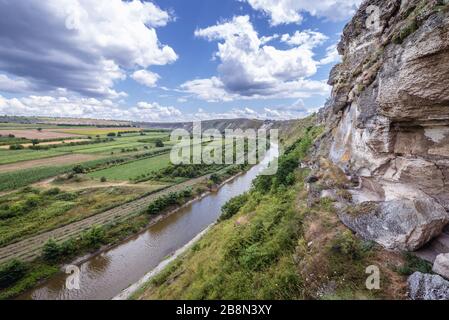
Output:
[{"left": 316, "top": 0, "right": 449, "bottom": 251}]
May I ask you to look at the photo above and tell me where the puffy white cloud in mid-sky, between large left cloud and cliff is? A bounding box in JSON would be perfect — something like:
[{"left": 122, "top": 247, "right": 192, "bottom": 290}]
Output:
[{"left": 181, "top": 16, "right": 328, "bottom": 101}]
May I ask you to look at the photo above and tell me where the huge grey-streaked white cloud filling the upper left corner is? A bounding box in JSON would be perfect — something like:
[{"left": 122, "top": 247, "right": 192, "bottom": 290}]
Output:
[{"left": 0, "top": 0, "right": 177, "bottom": 98}]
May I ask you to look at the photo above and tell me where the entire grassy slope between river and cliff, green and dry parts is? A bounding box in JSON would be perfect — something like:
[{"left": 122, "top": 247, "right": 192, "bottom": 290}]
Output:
[{"left": 134, "top": 119, "right": 405, "bottom": 299}]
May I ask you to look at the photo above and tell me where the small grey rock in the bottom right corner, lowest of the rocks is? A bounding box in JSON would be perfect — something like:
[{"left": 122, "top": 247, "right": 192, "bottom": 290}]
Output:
[{"left": 407, "top": 272, "right": 449, "bottom": 300}]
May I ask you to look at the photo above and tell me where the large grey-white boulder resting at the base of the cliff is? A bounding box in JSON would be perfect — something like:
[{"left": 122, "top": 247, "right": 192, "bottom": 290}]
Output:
[{"left": 339, "top": 199, "right": 449, "bottom": 251}]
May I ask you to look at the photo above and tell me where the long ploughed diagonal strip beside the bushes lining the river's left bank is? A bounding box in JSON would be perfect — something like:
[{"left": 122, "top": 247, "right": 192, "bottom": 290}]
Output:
[{"left": 0, "top": 175, "right": 210, "bottom": 264}]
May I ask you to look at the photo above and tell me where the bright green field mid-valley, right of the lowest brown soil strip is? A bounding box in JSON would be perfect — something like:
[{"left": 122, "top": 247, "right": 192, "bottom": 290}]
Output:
[{"left": 89, "top": 154, "right": 170, "bottom": 181}]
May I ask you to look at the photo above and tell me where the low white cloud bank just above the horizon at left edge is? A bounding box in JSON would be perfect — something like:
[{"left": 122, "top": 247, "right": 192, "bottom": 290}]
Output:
[{"left": 0, "top": 95, "right": 182, "bottom": 121}]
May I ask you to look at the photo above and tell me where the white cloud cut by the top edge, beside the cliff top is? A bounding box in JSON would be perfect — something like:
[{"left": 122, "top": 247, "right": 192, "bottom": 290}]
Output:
[{"left": 240, "top": 0, "right": 363, "bottom": 26}]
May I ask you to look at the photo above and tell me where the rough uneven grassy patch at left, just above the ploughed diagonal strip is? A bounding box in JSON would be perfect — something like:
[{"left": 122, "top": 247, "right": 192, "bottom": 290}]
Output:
[{"left": 0, "top": 185, "right": 154, "bottom": 246}]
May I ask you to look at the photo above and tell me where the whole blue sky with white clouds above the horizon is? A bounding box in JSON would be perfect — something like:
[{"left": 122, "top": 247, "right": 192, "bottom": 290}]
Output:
[{"left": 0, "top": 0, "right": 360, "bottom": 121}]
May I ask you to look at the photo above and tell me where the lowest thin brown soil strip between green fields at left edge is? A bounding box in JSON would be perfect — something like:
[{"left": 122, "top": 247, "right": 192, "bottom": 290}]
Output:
[{"left": 0, "top": 154, "right": 100, "bottom": 173}]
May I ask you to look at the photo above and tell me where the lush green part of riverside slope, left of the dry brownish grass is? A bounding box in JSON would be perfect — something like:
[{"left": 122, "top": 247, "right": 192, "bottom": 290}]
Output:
[{"left": 136, "top": 188, "right": 301, "bottom": 299}]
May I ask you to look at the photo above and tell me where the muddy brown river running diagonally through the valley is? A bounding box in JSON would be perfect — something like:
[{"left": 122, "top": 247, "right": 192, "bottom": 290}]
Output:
[{"left": 19, "top": 145, "right": 279, "bottom": 300}]
